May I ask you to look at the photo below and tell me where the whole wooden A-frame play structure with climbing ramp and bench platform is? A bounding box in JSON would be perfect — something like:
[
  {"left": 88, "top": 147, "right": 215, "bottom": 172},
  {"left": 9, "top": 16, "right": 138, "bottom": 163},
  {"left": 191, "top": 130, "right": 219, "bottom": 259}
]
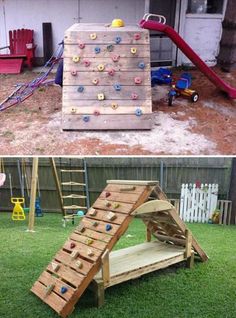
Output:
[{"left": 31, "top": 180, "right": 207, "bottom": 317}]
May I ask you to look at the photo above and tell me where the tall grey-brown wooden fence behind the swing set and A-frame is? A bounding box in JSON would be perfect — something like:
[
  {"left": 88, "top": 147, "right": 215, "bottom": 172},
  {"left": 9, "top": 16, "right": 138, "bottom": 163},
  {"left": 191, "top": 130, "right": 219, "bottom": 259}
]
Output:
[{"left": 0, "top": 157, "right": 232, "bottom": 212}]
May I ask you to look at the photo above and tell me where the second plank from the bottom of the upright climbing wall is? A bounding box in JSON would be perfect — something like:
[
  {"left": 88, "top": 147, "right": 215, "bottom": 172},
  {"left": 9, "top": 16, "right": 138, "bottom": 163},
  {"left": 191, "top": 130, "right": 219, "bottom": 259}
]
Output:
[{"left": 62, "top": 104, "right": 152, "bottom": 116}]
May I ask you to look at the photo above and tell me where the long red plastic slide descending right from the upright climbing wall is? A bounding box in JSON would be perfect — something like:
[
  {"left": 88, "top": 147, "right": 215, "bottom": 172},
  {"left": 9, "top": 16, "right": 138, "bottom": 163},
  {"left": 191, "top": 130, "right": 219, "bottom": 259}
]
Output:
[{"left": 139, "top": 20, "right": 236, "bottom": 98}]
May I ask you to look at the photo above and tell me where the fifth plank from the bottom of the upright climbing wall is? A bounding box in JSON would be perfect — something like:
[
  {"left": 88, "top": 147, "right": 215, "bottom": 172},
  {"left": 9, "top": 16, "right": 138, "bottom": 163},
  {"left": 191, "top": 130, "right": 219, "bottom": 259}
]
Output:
[{"left": 64, "top": 57, "right": 151, "bottom": 72}]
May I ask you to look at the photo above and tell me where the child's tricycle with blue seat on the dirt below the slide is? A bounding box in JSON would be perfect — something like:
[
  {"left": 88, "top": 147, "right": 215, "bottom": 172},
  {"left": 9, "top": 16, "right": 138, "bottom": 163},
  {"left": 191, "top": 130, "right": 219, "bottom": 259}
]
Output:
[{"left": 168, "top": 73, "right": 199, "bottom": 106}]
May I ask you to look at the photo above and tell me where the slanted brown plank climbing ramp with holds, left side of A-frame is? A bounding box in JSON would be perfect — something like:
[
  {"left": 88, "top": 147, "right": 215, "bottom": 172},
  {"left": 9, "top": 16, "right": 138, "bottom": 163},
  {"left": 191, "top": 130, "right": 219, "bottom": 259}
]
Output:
[{"left": 31, "top": 181, "right": 156, "bottom": 317}]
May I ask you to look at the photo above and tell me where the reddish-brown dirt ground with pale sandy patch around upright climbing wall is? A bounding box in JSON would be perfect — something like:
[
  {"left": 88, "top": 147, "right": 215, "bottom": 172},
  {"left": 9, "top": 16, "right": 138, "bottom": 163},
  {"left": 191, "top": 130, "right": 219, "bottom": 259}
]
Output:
[{"left": 0, "top": 68, "right": 236, "bottom": 155}]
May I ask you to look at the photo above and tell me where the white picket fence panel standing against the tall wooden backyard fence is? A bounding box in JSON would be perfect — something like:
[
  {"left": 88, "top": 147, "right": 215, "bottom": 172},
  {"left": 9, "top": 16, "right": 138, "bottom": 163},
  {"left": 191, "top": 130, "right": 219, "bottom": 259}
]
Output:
[{"left": 180, "top": 183, "right": 218, "bottom": 223}]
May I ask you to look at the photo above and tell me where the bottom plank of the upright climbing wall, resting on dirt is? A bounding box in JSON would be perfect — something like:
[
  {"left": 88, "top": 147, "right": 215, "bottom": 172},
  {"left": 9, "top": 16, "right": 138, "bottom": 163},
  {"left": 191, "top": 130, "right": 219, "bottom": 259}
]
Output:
[{"left": 62, "top": 114, "right": 153, "bottom": 130}]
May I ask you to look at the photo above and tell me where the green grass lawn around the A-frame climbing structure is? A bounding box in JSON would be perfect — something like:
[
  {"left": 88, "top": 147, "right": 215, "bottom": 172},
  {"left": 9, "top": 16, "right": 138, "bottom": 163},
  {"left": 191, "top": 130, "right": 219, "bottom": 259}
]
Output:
[{"left": 0, "top": 213, "right": 236, "bottom": 318}]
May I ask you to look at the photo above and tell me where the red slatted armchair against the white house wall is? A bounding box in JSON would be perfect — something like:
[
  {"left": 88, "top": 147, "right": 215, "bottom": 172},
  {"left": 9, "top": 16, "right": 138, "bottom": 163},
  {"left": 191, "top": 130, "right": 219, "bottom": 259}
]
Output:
[{"left": 0, "top": 29, "right": 36, "bottom": 73}]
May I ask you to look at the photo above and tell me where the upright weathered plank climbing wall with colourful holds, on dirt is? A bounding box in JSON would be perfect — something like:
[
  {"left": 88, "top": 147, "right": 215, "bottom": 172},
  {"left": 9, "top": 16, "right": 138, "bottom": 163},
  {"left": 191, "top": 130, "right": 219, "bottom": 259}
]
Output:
[{"left": 62, "top": 23, "right": 152, "bottom": 130}]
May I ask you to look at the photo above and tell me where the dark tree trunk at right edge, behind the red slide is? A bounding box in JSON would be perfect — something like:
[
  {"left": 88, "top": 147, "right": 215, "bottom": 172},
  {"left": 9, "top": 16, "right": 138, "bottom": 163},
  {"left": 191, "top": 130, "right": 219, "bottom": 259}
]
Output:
[{"left": 218, "top": 0, "right": 236, "bottom": 72}]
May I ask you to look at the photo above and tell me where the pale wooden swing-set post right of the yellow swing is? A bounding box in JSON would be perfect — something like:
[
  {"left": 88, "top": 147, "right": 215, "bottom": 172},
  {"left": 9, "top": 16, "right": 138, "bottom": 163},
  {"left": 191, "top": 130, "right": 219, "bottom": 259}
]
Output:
[{"left": 28, "top": 157, "right": 39, "bottom": 232}]
